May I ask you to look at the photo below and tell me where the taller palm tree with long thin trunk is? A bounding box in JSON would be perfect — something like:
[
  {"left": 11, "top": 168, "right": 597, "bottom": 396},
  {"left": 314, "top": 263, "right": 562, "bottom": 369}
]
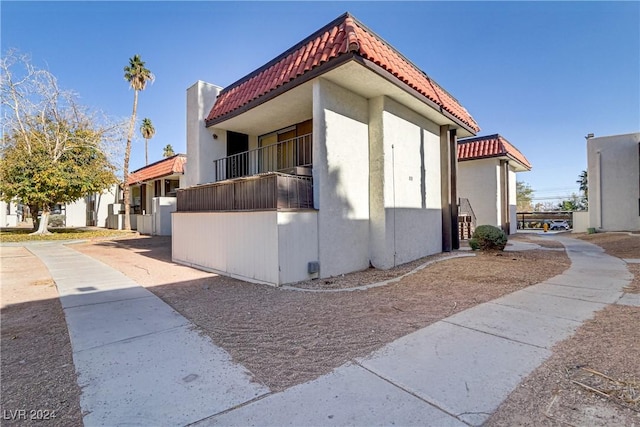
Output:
[{"left": 123, "top": 55, "right": 155, "bottom": 230}]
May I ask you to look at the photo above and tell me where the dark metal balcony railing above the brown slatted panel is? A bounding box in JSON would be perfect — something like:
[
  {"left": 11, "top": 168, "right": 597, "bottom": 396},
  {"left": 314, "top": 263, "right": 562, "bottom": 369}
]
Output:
[{"left": 213, "top": 133, "right": 313, "bottom": 181}]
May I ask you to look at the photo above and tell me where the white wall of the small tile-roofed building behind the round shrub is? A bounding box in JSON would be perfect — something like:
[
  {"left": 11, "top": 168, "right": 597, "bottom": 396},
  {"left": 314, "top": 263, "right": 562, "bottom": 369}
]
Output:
[{"left": 458, "top": 159, "right": 502, "bottom": 227}]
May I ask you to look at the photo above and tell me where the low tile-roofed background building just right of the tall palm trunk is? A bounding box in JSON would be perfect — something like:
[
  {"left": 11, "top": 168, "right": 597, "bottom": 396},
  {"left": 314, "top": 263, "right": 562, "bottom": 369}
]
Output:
[{"left": 118, "top": 154, "right": 187, "bottom": 236}]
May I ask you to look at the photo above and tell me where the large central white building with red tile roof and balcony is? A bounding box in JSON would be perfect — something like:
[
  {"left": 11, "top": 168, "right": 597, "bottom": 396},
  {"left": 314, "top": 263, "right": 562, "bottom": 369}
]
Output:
[{"left": 172, "top": 14, "right": 479, "bottom": 285}]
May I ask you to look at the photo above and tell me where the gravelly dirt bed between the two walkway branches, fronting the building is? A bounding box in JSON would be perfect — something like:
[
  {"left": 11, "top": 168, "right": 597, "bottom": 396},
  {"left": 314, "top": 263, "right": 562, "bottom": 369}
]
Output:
[{"left": 74, "top": 238, "right": 570, "bottom": 390}]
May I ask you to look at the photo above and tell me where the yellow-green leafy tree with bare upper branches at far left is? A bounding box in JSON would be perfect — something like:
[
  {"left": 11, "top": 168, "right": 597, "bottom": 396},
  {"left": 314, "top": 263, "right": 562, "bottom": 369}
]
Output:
[{"left": 0, "top": 51, "right": 122, "bottom": 234}]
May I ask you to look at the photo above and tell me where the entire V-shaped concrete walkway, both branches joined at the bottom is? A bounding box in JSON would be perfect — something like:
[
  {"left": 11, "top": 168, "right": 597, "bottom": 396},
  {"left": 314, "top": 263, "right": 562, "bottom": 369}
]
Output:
[{"left": 28, "top": 236, "right": 632, "bottom": 426}]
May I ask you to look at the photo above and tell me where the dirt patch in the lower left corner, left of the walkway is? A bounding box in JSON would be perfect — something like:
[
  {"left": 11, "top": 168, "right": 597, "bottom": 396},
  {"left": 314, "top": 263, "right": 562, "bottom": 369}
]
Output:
[{"left": 0, "top": 247, "right": 82, "bottom": 426}]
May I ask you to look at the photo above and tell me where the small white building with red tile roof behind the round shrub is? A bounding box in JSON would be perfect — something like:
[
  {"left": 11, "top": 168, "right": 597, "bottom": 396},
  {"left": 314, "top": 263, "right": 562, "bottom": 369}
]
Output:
[{"left": 458, "top": 134, "right": 531, "bottom": 234}]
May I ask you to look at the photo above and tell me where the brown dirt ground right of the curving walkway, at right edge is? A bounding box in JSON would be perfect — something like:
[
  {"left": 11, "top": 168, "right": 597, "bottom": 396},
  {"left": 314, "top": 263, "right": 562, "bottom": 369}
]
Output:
[{"left": 486, "top": 233, "right": 640, "bottom": 427}]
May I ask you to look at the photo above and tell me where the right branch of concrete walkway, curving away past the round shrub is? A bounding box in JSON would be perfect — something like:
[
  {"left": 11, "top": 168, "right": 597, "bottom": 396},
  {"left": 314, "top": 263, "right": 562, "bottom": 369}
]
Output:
[{"left": 197, "top": 237, "right": 632, "bottom": 426}]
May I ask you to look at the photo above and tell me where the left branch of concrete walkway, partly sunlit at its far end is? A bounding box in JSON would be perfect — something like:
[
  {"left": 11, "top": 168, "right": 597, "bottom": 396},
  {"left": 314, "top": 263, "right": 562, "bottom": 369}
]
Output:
[{"left": 26, "top": 243, "right": 269, "bottom": 426}]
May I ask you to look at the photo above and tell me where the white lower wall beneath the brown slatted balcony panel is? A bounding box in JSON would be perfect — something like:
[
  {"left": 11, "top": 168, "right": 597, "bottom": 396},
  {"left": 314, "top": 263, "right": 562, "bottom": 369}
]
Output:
[{"left": 172, "top": 211, "right": 318, "bottom": 285}]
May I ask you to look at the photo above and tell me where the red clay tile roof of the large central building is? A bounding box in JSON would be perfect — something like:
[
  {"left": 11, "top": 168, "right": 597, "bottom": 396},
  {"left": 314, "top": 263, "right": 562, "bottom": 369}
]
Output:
[{"left": 206, "top": 13, "right": 480, "bottom": 133}]
